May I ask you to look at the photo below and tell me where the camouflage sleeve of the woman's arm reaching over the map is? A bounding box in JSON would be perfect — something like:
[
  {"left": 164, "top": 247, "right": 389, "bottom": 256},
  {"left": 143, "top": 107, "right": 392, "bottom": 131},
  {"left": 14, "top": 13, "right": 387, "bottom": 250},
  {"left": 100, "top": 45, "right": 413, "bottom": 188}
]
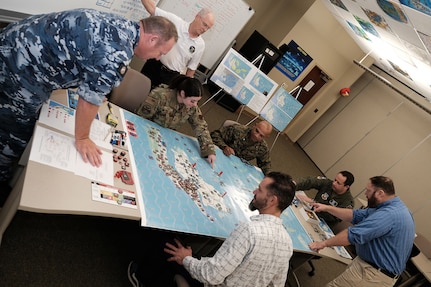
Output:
[{"left": 188, "top": 107, "right": 216, "bottom": 157}]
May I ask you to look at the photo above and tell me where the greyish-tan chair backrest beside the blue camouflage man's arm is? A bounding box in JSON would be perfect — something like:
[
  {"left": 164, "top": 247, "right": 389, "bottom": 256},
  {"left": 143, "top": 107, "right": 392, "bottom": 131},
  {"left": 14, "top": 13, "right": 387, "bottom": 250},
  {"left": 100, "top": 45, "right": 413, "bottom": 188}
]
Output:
[{"left": 109, "top": 68, "right": 151, "bottom": 113}]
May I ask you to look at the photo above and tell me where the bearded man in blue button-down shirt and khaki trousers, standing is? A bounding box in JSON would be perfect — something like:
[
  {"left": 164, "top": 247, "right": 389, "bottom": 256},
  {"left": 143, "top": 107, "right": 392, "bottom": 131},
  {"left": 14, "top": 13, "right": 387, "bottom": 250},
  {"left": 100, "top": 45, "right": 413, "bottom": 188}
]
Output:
[{"left": 310, "top": 176, "right": 415, "bottom": 287}]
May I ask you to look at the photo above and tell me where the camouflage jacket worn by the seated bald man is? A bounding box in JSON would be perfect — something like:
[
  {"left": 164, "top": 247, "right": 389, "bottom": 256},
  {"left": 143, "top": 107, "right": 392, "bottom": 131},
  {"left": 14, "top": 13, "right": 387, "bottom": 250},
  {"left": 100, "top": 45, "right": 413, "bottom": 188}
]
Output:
[{"left": 211, "top": 124, "right": 271, "bottom": 174}]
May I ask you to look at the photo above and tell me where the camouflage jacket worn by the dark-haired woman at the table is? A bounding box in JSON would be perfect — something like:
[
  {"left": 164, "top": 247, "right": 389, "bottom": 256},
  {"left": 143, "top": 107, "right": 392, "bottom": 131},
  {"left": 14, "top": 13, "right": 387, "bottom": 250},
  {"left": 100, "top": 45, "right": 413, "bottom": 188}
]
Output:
[{"left": 137, "top": 85, "right": 215, "bottom": 157}]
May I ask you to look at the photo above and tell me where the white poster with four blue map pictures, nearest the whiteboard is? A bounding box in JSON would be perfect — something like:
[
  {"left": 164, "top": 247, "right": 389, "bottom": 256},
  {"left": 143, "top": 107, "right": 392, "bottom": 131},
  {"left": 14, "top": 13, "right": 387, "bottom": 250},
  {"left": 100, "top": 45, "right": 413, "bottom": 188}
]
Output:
[{"left": 211, "top": 49, "right": 278, "bottom": 114}]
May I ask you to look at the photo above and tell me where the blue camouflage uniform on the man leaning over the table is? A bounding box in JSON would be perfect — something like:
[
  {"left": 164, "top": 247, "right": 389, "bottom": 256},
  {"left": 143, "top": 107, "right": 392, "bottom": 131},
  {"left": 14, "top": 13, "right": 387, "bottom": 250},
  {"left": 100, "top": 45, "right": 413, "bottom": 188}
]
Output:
[{"left": 0, "top": 9, "right": 140, "bottom": 181}]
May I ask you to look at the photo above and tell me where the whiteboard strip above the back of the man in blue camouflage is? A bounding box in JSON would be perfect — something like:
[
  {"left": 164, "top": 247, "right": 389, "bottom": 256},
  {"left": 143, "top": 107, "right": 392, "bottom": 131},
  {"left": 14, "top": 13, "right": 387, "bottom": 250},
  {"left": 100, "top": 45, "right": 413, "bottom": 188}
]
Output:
[{"left": 1, "top": 0, "right": 158, "bottom": 21}]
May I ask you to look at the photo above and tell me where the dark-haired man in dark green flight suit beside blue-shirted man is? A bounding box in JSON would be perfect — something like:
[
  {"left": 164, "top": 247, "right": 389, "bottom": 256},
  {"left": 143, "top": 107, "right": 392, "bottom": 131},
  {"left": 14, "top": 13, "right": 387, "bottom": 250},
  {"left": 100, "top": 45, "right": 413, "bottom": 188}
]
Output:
[{"left": 296, "top": 171, "right": 355, "bottom": 228}]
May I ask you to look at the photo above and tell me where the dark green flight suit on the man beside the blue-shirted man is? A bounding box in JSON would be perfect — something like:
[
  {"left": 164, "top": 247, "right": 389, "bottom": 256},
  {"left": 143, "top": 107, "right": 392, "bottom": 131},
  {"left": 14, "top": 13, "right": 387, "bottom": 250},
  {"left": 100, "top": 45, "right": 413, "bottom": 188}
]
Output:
[{"left": 296, "top": 176, "right": 354, "bottom": 227}]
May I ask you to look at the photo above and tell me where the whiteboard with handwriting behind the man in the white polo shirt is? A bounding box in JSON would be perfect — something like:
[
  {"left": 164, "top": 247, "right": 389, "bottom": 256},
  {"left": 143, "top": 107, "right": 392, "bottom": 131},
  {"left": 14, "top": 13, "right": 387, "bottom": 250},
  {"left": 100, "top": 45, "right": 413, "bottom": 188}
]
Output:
[{"left": 158, "top": 0, "right": 254, "bottom": 70}]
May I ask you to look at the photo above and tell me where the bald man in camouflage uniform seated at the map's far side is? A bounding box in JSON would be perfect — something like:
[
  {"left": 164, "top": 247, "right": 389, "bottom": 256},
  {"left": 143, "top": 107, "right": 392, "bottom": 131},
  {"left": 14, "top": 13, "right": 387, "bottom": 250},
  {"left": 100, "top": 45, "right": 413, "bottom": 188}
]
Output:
[{"left": 211, "top": 121, "right": 272, "bottom": 174}]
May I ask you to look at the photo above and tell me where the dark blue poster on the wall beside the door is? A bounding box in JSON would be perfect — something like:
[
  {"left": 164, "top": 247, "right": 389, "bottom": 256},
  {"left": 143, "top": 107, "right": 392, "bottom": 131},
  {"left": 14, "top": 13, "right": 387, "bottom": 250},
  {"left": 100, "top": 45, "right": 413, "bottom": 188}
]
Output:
[{"left": 275, "top": 40, "right": 313, "bottom": 81}]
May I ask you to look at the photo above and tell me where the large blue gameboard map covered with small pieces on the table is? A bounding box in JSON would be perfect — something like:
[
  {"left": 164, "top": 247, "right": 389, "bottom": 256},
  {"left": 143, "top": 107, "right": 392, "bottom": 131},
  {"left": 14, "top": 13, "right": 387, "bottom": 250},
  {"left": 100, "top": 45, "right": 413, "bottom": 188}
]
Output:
[{"left": 122, "top": 110, "right": 311, "bottom": 251}]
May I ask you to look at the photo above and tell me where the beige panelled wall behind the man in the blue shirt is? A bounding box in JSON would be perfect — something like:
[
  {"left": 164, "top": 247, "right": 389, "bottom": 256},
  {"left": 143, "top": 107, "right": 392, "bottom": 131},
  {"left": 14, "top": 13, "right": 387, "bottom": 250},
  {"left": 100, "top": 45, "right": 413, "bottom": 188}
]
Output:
[{"left": 298, "top": 70, "right": 431, "bottom": 240}]
